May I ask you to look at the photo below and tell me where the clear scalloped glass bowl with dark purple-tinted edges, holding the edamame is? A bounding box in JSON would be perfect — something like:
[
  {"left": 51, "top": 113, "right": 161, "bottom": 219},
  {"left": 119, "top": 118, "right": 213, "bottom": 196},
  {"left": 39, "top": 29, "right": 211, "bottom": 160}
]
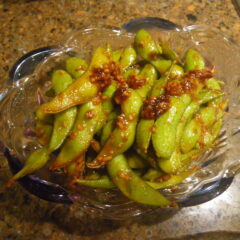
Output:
[{"left": 0, "top": 18, "right": 240, "bottom": 219}]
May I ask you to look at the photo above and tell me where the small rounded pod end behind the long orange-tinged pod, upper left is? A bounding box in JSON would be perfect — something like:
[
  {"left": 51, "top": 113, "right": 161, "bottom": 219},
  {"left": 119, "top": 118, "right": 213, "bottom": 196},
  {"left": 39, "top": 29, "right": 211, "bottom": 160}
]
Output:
[{"left": 65, "top": 57, "right": 88, "bottom": 78}]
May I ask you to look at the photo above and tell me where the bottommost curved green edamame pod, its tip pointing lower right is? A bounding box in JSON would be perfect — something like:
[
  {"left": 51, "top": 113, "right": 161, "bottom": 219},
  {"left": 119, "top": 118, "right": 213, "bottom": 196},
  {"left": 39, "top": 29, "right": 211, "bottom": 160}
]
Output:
[{"left": 107, "top": 155, "right": 171, "bottom": 207}]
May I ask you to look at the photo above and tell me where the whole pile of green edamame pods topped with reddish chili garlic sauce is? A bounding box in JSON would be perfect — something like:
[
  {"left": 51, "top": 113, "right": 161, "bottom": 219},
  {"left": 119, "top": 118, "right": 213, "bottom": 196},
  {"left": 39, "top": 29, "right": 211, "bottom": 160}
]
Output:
[{"left": 9, "top": 29, "right": 227, "bottom": 207}]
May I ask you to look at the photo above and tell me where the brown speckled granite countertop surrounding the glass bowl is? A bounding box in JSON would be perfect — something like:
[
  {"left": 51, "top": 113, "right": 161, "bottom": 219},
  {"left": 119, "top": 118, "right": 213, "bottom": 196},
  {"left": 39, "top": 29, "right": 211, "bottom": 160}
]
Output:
[{"left": 0, "top": 0, "right": 240, "bottom": 240}]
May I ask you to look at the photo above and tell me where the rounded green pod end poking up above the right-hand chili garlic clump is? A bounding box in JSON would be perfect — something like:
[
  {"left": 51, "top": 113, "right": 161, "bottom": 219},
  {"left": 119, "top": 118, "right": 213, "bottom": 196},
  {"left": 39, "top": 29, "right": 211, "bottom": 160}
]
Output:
[{"left": 184, "top": 48, "right": 205, "bottom": 72}]
